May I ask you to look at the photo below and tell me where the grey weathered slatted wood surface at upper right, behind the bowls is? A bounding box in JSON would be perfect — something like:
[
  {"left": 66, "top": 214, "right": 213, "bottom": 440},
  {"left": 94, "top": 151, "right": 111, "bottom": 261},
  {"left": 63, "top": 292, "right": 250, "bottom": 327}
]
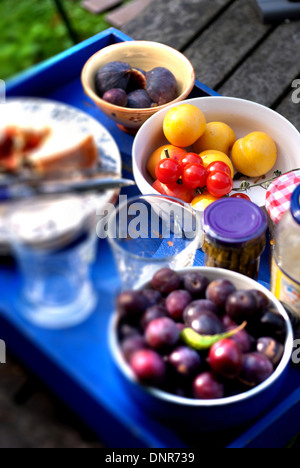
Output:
[{"left": 122, "top": 0, "right": 300, "bottom": 131}]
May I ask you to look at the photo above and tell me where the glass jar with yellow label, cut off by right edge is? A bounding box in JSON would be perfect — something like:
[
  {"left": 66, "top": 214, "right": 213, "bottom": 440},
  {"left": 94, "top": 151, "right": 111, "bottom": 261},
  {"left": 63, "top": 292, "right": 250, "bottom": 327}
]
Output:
[{"left": 271, "top": 184, "right": 300, "bottom": 322}]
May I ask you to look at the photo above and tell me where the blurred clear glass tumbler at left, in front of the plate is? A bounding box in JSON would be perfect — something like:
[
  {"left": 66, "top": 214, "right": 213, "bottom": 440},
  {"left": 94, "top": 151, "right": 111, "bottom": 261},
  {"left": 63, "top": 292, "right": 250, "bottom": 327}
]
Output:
[{"left": 9, "top": 198, "right": 97, "bottom": 328}]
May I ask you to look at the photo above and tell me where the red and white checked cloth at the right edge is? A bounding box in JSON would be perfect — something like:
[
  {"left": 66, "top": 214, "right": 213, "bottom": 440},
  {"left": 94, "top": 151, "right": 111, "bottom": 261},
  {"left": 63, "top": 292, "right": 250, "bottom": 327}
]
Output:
[{"left": 266, "top": 170, "right": 300, "bottom": 224}]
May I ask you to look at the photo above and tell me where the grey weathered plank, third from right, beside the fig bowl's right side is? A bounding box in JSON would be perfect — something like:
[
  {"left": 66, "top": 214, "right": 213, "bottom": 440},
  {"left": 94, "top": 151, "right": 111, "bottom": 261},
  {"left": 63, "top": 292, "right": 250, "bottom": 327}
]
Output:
[{"left": 184, "top": 0, "right": 270, "bottom": 89}]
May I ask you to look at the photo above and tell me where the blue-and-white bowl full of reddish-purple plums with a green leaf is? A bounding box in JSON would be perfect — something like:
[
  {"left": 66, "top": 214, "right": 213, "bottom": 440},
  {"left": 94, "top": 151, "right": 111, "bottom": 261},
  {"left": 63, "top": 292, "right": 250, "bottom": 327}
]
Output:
[{"left": 109, "top": 267, "right": 293, "bottom": 432}]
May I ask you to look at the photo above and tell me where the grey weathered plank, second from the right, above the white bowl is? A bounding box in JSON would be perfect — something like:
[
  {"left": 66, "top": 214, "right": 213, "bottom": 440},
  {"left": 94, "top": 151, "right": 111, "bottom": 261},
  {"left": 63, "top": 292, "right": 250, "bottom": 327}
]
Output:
[{"left": 219, "top": 21, "right": 300, "bottom": 107}]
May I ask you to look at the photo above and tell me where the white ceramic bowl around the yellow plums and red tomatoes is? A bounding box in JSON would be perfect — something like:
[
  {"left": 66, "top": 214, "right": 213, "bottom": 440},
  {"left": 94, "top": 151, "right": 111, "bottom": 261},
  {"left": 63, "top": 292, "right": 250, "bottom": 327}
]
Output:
[{"left": 132, "top": 96, "right": 300, "bottom": 207}]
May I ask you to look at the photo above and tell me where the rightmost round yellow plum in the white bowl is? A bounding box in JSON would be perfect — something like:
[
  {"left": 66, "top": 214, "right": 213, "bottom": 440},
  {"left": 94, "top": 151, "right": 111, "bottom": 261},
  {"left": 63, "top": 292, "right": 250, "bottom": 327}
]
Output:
[{"left": 231, "top": 132, "right": 277, "bottom": 177}]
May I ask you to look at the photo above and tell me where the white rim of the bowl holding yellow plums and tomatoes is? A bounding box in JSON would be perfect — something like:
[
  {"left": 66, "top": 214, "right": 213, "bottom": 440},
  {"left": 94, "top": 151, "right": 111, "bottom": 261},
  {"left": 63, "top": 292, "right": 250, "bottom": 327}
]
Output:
[{"left": 132, "top": 95, "right": 300, "bottom": 205}]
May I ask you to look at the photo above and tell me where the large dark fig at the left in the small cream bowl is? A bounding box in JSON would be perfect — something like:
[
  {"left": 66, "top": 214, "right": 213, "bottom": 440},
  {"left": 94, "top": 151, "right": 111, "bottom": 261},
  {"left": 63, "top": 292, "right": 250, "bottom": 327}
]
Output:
[{"left": 95, "top": 62, "right": 131, "bottom": 97}]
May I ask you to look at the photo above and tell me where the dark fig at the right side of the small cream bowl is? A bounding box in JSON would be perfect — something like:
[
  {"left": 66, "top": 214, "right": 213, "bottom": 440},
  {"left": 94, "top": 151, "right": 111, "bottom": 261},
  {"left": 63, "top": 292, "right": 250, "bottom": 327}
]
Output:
[{"left": 146, "top": 67, "right": 178, "bottom": 106}]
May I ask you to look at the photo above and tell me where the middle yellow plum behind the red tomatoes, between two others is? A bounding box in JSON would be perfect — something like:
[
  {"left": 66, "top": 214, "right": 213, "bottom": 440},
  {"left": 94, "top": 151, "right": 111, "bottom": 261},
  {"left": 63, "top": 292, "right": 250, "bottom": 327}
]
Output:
[{"left": 193, "top": 122, "right": 236, "bottom": 155}]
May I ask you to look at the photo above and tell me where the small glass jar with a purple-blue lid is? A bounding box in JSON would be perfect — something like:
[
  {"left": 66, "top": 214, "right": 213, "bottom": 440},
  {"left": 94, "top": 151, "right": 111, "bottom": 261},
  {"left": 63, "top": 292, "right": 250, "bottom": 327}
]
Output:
[{"left": 202, "top": 198, "right": 268, "bottom": 279}]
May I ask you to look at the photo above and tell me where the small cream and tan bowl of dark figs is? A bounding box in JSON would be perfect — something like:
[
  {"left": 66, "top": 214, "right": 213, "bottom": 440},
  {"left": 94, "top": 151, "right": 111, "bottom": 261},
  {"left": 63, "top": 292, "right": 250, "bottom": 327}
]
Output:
[{"left": 81, "top": 41, "right": 195, "bottom": 134}]
